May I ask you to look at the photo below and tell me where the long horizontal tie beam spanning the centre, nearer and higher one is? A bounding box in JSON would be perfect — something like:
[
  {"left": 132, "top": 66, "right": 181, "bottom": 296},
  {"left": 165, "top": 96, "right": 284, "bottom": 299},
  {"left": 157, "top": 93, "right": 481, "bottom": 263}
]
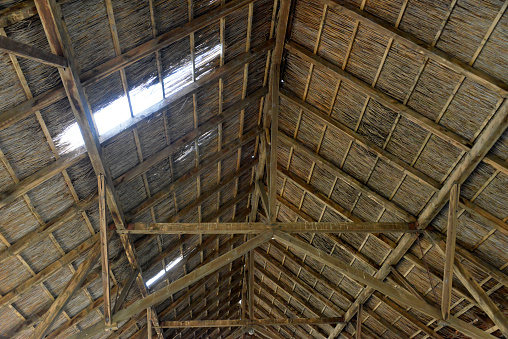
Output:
[{"left": 117, "top": 222, "right": 423, "bottom": 234}]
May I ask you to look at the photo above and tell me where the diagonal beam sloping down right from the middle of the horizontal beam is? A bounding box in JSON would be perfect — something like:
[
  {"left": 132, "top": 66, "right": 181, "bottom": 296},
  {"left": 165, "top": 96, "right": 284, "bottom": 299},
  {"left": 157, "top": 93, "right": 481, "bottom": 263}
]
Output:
[{"left": 274, "top": 231, "right": 493, "bottom": 338}]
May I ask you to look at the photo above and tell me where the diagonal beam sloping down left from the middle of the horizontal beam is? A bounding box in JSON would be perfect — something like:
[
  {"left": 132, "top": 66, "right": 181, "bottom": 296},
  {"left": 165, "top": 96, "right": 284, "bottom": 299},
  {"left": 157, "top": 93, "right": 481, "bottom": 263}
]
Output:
[{"left": 71, "top": 232, "right": 273, "bottom": 339}]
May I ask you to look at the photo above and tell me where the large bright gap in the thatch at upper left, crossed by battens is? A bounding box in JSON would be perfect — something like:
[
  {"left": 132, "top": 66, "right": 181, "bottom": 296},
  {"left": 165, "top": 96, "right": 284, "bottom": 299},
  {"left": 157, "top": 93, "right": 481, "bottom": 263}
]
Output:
[{"left": 55, "top": 44, "right": 222, "bottom": 153}]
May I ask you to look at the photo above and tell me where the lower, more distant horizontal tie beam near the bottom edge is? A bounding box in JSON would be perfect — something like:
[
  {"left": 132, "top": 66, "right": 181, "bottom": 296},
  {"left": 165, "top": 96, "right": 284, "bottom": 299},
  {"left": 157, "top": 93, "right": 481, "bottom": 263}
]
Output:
[{"left": 160, "top": 317, "right": 344, "bottom": 328}]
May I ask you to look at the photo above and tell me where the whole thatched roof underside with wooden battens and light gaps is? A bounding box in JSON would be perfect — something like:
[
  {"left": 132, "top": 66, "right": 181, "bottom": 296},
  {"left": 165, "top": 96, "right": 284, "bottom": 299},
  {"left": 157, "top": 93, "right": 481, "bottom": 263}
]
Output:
[{"left": 0, "top": 0, "right": 508, "bottom": 338}]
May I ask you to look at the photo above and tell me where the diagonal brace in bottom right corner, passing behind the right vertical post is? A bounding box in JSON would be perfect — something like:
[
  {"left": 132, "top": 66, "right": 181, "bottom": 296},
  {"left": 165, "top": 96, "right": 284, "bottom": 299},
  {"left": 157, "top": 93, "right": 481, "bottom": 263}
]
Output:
[{"left": 429, "top": 232, "right": 508, "bottom": 336}]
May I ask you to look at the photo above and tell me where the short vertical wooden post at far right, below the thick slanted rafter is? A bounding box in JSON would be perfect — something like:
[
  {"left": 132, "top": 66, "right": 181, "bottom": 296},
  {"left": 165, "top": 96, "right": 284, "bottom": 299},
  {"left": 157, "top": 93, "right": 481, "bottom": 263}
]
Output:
[{"left": 441, "top": 183, "right": 460, "bottom": 320}]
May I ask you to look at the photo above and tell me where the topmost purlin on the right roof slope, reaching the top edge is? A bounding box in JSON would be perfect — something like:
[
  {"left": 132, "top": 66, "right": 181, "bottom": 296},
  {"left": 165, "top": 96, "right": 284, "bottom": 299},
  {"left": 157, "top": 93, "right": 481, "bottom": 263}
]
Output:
[{"left": 321, "top": 0, "right": 508, "bottom": 97}]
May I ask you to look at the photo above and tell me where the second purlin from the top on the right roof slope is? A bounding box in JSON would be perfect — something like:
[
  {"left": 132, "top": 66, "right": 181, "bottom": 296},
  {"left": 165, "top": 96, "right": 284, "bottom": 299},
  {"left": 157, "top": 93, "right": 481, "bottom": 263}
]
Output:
[{"left": 286, "top": 42, "right": 508, "bottom": 173}]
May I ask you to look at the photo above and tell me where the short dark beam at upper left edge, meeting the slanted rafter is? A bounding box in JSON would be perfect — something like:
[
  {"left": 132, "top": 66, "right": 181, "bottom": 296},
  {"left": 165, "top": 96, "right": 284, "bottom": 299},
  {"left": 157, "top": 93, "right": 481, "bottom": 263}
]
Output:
[{"left": 0, "top": 35, "right": 67, "bottom": 67}]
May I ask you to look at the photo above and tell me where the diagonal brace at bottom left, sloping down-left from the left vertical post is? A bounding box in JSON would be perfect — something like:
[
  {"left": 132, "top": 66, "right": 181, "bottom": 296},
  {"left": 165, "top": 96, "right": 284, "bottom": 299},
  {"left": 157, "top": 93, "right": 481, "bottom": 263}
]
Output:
[{"left": 32, "top": 242, "right": 101, "bottom": 339}]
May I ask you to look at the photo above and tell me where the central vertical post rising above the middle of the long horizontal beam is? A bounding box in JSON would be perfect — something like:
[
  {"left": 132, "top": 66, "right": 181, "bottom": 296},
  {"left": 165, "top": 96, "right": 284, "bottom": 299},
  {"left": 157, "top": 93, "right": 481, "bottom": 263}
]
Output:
[{"left": 268, "top": 64, "right": 280, "bottom": 222}]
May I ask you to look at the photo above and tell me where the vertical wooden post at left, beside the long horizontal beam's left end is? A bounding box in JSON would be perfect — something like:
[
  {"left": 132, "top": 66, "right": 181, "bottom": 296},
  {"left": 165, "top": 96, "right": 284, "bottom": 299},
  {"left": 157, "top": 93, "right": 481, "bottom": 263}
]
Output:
[{"left": 97, "top": 174, "right": 111, "bottom": 328}]
